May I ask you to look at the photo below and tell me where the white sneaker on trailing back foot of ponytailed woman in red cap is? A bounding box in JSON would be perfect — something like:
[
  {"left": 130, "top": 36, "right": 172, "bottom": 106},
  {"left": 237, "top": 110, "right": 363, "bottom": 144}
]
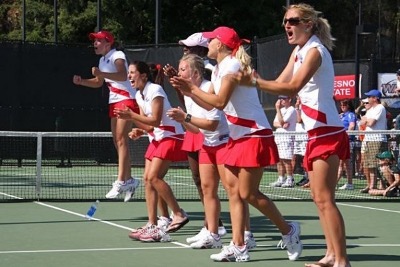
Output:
[{"left": 277, "top": 222, "right": 303, "bottom": 261}]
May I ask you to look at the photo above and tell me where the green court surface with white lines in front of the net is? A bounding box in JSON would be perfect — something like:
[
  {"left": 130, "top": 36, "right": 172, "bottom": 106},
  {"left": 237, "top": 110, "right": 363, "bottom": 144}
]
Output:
[{"left": 0, "top": 196, "right": 400, "bottom": 267}]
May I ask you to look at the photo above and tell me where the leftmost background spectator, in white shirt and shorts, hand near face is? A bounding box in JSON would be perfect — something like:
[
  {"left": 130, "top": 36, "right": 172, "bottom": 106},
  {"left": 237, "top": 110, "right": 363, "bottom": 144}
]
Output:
[{"left": 270, "top": 95, "right": 297, "bottom": 187}]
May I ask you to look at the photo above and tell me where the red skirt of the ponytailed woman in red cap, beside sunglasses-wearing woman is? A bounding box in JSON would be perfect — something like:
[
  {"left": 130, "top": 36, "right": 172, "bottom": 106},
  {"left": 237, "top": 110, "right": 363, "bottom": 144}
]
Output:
[{"left": 224, "top": 129, "right": 279, "bottom": 168}]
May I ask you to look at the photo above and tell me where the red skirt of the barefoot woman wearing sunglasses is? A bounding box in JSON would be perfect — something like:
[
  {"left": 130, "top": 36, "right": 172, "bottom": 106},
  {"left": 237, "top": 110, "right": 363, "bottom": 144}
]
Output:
[{"left": 303, "top": 127, "right": 350, "bottom": 171}]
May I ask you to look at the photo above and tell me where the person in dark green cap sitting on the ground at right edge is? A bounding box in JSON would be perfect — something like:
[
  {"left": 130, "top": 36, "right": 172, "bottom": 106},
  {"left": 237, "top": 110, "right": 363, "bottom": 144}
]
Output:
[{"left": 368, "top": 151, "right": 400, "bottom": 197}]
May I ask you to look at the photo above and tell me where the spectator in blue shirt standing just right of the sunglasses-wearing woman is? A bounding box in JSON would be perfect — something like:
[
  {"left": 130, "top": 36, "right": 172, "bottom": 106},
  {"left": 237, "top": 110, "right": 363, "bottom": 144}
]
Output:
[{"left": 337, "top": 100, "right": 357, "bottom": 190}]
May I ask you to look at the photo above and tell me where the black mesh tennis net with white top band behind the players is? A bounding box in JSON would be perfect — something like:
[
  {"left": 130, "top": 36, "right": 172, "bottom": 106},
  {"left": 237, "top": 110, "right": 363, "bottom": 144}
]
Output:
[{"left": 0, "top": 131, "right": 400, "bottom": 202}]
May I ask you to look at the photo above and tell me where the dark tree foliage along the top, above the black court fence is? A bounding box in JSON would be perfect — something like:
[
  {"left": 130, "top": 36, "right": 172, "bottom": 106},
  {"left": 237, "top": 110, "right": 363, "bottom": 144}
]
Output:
[{"left": 0, "top": 0, "right": 400, "bottom": 59}]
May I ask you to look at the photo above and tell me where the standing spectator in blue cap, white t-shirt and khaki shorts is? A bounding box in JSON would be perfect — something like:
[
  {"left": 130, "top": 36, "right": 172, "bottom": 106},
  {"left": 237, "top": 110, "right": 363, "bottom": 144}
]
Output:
[{"left": 360, "top": 89, "right": 387, "bottom": 193}]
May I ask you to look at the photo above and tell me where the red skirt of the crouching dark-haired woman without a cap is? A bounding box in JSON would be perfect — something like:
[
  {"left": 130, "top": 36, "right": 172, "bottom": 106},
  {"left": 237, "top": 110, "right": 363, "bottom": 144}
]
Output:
[{"left": 144, "top": 134, "right": 187, "bottom": 161}]
